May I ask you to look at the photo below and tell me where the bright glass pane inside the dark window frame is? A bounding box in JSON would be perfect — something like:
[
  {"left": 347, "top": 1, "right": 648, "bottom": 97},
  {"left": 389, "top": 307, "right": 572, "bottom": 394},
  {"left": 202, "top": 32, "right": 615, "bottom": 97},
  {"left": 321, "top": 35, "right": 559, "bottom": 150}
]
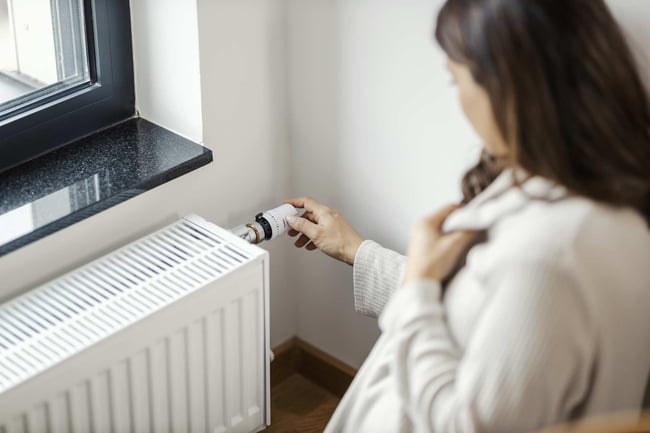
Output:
[{"left": 0, "top": 0, "right": 89, "bottom": 115}]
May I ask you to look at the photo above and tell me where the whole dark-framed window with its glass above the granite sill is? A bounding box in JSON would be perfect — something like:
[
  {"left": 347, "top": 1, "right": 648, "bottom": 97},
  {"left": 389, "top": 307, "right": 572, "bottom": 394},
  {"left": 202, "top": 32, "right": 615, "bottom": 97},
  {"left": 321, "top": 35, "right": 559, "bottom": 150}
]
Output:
[{"left": 0, "top": 0, "right": 135, "bottom": 171}]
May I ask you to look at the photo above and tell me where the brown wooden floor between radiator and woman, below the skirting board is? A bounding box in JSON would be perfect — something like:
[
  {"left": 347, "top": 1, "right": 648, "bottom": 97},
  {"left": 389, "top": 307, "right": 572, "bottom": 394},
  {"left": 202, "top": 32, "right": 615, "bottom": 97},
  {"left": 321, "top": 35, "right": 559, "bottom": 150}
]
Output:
[{"left": 264, "top": 374, "right": 340, "bottom": 433}]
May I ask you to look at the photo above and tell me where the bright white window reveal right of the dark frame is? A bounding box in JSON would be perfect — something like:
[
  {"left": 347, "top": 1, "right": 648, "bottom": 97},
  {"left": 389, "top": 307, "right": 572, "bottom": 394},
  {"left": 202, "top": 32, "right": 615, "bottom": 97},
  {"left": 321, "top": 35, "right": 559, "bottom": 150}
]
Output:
[{"left": 131, "top": 0, "right": 203, "bottom": 143}]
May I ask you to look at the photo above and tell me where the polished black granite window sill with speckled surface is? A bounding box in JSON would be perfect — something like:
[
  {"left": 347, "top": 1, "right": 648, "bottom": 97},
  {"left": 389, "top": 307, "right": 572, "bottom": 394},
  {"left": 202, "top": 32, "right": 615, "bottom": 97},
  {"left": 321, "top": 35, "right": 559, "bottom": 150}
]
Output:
[{"left": 0, "top": 118, "right": 212, "bottom": 256}]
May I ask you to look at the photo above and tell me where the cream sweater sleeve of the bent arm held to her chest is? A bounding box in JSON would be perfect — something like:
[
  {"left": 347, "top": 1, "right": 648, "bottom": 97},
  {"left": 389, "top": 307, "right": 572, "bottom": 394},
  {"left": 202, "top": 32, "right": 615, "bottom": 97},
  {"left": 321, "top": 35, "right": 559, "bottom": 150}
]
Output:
[{"left": 379, "top": 264, "right": 596, "bottom": 433}]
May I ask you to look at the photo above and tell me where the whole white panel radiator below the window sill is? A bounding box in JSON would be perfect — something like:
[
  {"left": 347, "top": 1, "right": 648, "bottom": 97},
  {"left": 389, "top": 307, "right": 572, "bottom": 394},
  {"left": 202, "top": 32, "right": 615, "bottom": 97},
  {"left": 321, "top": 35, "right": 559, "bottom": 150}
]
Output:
[{"left": 0, "top": 216, "right": 270, "bottom": 433}]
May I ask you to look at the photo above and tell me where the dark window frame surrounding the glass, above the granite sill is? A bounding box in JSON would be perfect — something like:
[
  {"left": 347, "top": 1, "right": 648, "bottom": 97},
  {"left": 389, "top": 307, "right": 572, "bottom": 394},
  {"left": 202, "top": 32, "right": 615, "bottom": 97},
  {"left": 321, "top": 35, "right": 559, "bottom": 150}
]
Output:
[{"left": 0, "top": 0, "right": 135, "bottom": 172}]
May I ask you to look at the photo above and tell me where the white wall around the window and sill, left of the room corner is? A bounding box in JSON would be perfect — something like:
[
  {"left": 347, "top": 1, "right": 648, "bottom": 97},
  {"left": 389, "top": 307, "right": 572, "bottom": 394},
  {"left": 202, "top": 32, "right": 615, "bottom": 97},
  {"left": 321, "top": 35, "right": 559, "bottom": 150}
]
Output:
[{"left": 0, "top": 0, "right": 296, "bottom": 345}]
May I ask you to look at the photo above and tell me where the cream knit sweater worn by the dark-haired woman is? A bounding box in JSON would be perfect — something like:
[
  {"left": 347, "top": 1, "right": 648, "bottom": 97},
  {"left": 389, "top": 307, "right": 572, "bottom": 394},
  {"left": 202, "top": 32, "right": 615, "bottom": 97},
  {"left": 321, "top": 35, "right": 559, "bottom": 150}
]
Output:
[{"left": 325, "top": 171, "right": 650, "bottom": 433}]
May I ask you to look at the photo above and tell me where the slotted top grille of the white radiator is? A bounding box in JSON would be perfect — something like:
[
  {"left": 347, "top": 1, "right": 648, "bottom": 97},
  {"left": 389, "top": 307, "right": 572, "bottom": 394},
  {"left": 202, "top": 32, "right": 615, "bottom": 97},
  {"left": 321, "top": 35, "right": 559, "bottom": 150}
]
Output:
[{"left": 0, "top": 220, "right": 250, "bottom": 393}]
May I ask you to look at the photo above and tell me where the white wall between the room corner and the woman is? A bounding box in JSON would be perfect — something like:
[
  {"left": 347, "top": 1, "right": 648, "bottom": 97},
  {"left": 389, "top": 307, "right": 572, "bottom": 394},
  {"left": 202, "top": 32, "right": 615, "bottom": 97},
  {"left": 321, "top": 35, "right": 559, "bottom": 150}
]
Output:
[{"left": 289, "top": 0, "right": 479, "bottom": 366}]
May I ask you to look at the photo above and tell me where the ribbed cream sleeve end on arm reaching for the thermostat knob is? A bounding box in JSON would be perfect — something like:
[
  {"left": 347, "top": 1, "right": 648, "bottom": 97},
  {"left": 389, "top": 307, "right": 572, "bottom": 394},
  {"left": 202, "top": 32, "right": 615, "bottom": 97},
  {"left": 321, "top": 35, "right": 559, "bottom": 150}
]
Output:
[{"left": 353, "top": 241, "right": 406, "bottom": 317}]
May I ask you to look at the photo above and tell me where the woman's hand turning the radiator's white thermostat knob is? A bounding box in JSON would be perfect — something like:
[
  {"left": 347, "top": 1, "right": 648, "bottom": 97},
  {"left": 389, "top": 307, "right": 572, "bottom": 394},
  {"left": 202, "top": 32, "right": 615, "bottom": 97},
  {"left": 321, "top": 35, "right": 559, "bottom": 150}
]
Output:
[{"left": 286, "top": 197, "right": 363, "bottom": 265}]
